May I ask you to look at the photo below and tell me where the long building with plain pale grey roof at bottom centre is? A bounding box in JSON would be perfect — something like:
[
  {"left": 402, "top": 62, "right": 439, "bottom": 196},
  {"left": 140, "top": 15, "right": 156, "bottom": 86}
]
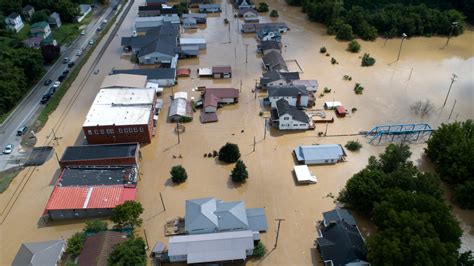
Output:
[{"left": 168, "top": 230, "right": 255, "bottom": 264}]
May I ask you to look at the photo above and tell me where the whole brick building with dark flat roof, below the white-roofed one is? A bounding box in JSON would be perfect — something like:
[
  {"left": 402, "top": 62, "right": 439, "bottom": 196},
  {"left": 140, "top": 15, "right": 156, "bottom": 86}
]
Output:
[{"left": 59, "top": 142, "right": 140, "bottom": 168}]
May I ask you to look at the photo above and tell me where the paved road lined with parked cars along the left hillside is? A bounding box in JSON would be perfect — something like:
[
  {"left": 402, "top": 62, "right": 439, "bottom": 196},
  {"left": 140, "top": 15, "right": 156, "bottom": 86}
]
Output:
[{"left": 0, "top": 3, "right": 119, "bottom": 171}]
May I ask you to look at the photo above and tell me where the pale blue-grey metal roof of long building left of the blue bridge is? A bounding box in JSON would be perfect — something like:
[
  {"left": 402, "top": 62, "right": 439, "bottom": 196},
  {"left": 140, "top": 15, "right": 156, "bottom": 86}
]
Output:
[{"left": 294, "top": 144, "right": 346, "bottom": 161}]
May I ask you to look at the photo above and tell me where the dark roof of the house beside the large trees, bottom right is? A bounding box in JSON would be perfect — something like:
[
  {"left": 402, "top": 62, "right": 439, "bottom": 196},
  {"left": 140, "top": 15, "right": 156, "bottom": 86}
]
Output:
[{"left": 317, "top": 221, "right": 367, "bottom": 265}]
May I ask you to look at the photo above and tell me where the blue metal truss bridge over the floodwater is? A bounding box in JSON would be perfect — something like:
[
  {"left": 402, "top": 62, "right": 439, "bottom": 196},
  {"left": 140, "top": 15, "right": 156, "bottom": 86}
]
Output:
[{"left": 366, "top": 124, "right": 433, "bottom": 144}]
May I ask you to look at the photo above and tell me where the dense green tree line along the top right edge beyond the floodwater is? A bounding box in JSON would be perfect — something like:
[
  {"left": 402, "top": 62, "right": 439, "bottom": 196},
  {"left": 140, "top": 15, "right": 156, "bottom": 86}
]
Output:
[{"left": 287, "top": 0, "right": 468, "bottom": 40}]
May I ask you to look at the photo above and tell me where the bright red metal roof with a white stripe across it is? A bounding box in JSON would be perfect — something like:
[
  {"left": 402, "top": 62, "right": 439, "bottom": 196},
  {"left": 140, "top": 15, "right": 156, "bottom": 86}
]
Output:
[{"left": 46, "top": 185, "right": 137, "bottom": 211}]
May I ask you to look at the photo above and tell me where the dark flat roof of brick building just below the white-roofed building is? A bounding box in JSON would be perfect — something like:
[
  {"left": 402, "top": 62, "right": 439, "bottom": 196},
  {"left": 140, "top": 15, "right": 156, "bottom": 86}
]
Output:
[{"left": 61, "top": 143, "right": 139, "bottom": 162}]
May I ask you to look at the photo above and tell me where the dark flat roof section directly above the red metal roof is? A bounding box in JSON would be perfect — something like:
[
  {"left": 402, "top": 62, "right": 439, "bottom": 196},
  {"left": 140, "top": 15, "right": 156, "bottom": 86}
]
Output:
[{"left": 58, "top": 167, "right": 137, "bottom": 187}]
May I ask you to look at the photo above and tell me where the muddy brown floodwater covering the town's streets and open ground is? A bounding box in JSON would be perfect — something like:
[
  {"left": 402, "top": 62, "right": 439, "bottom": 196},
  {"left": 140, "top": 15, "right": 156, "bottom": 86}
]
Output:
[{"left": 0, "top": 0, "right": 474, "bottom": 265}]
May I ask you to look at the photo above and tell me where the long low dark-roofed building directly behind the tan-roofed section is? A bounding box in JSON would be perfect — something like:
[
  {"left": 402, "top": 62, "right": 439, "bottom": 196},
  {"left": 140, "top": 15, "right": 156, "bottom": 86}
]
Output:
[{"left": 112, "top": 68, "right": 176, "bottom": 87}]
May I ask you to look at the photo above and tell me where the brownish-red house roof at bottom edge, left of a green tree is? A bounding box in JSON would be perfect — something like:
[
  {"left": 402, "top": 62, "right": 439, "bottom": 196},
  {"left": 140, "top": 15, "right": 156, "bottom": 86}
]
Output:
[{"left": 79, "top": 231, "right": 127, "bottom": 266}]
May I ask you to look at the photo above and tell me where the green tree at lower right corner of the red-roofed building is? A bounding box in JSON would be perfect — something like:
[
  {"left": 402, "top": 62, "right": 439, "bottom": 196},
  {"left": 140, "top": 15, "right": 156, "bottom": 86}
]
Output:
[{"left": 111, "top": 200, "right": 143, "bottom": 228}]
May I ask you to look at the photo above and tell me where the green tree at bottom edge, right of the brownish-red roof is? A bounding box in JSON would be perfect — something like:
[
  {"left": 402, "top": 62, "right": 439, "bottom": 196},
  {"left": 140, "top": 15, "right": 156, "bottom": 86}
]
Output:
[{"left": 108, "top": 237, "right": 146, "bottom": 266}]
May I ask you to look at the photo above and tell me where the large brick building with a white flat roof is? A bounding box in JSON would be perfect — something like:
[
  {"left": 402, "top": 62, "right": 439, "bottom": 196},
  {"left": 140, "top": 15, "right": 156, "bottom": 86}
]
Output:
[{"left": 82, "top": 88, "right": 156, "bottom": 144}]
